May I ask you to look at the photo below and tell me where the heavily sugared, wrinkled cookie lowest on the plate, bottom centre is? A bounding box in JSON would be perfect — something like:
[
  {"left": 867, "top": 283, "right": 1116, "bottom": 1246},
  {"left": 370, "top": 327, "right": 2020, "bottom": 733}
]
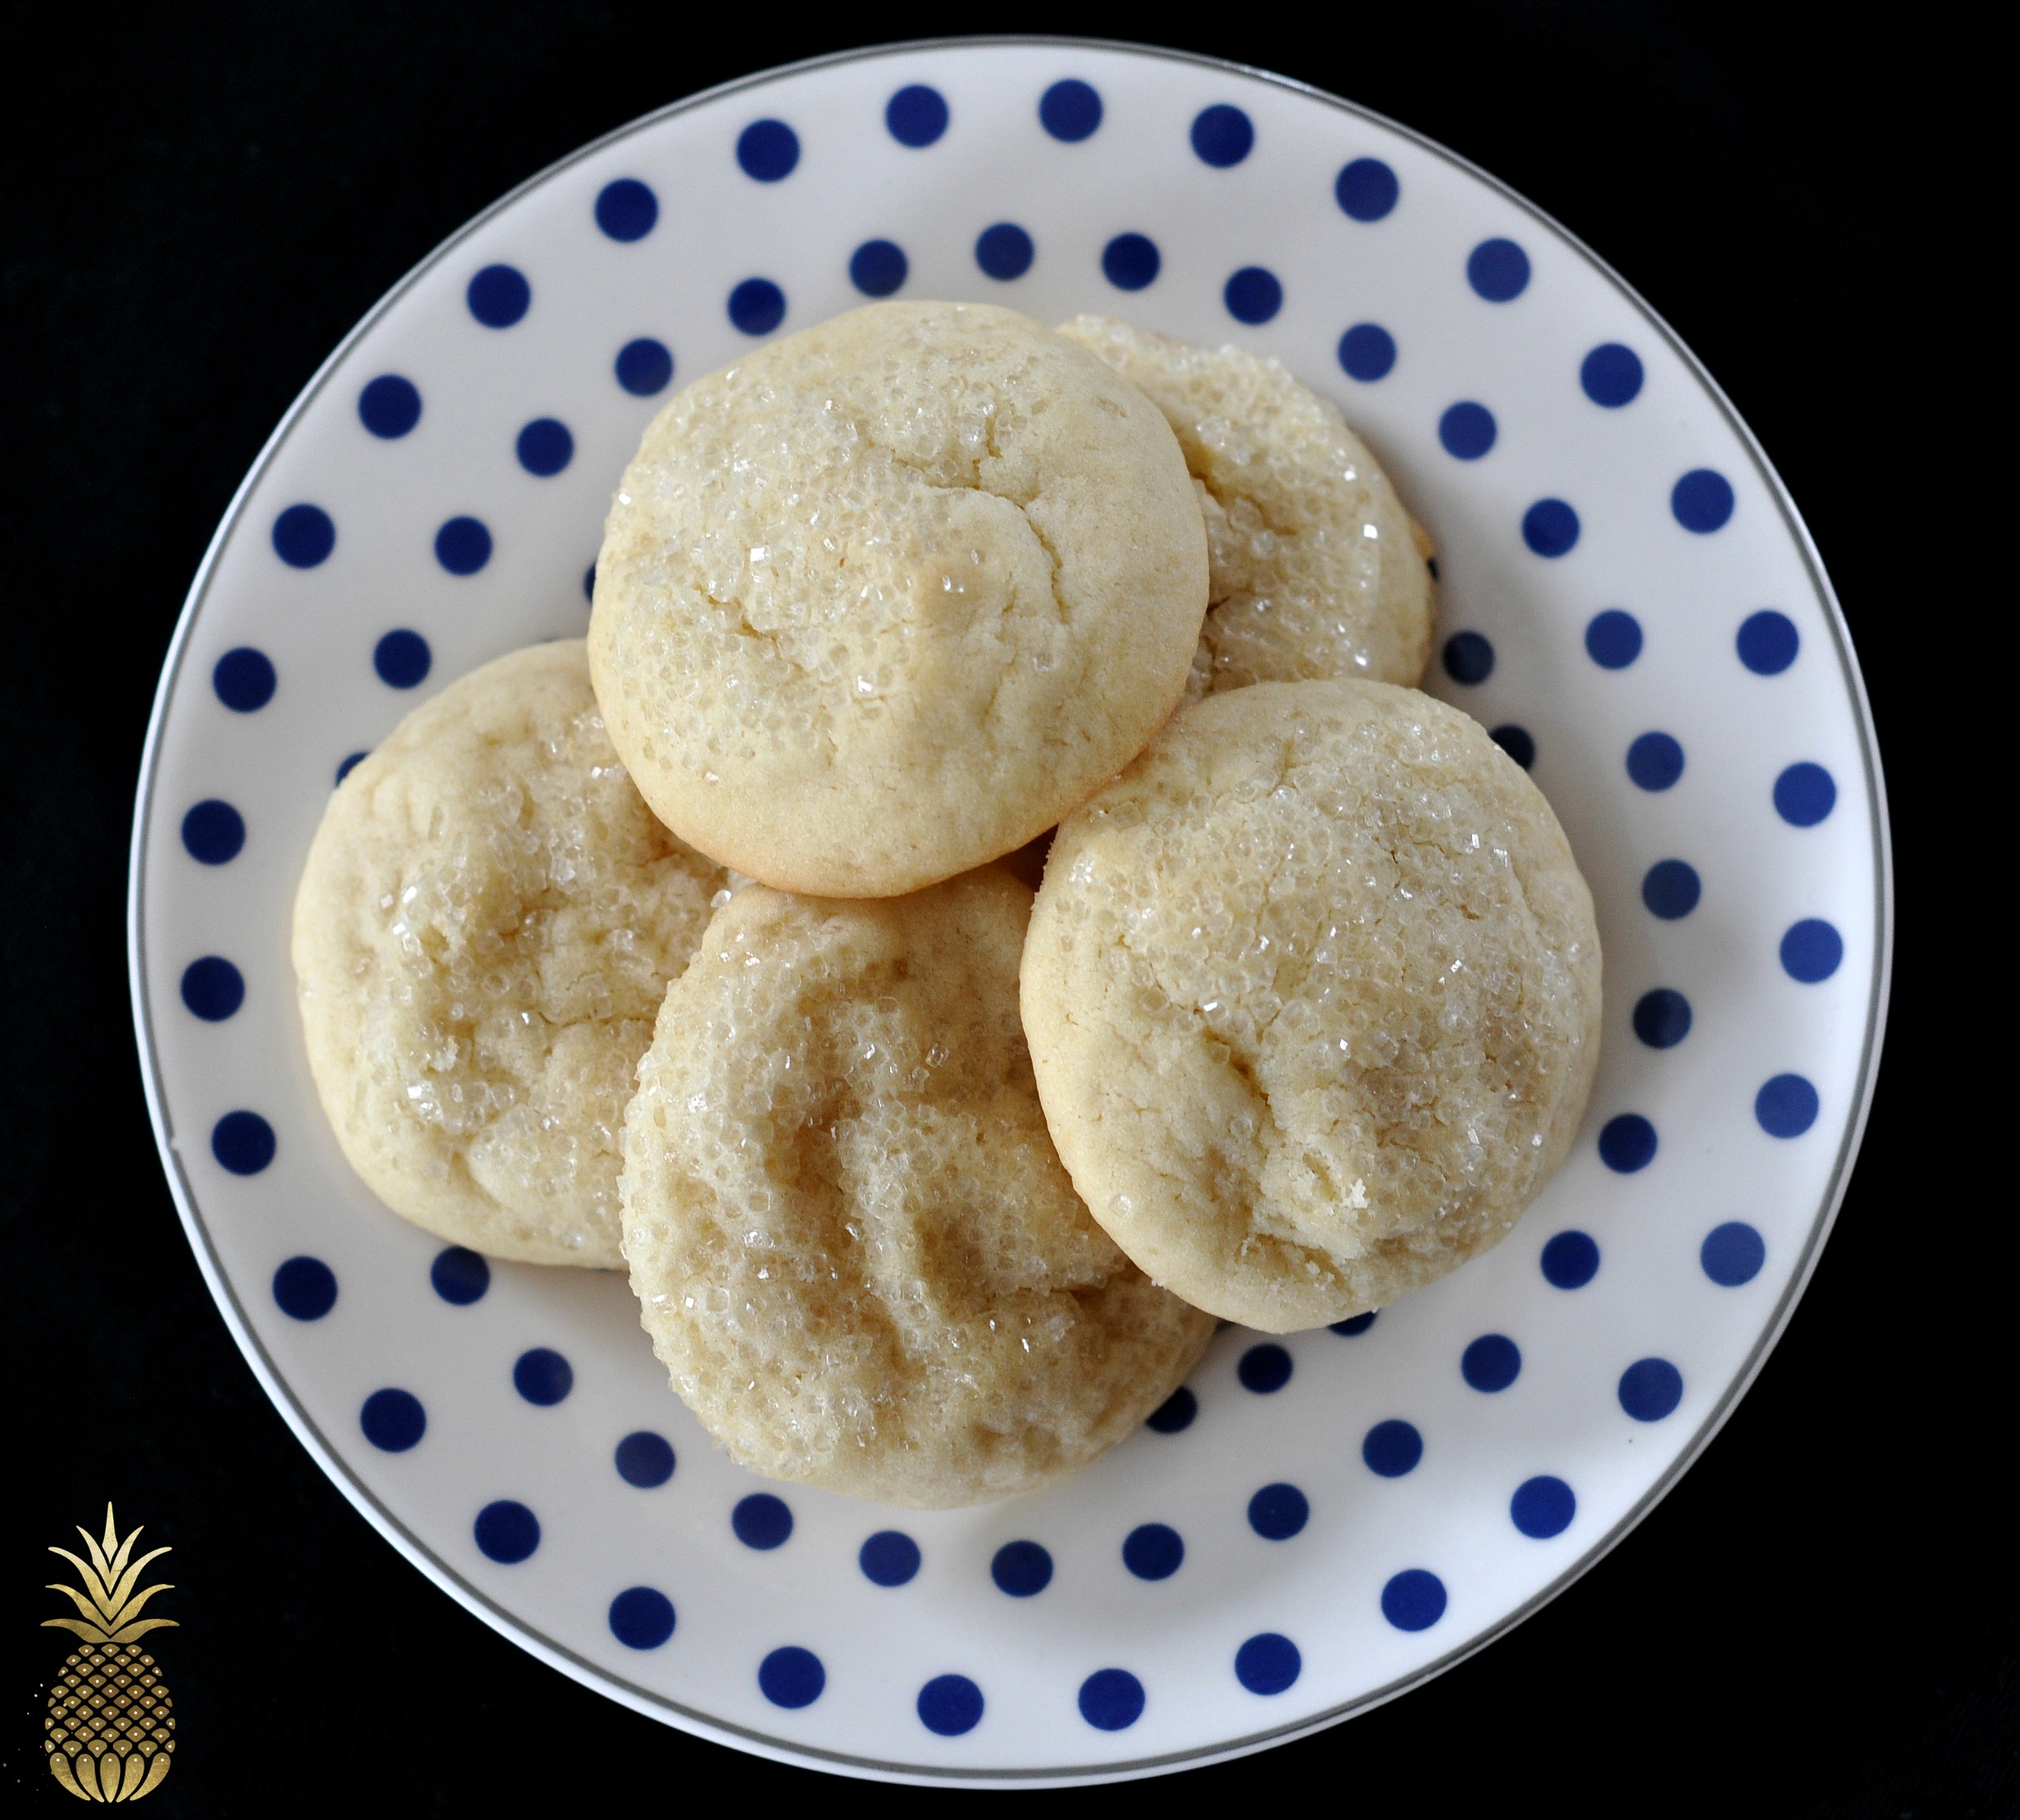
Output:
[{"left": 625, "top": 866, "right": 1214, "bottom": 1507}]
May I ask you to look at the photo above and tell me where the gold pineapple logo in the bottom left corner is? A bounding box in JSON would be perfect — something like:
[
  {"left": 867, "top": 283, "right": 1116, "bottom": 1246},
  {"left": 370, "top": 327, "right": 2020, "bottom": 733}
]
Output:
[{"left": 42, "top": 1505, "right": 175, "bottom": 1802}]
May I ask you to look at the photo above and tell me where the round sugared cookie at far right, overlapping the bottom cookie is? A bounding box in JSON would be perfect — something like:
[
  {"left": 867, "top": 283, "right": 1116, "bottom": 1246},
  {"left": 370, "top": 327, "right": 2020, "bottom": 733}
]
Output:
[{"left": 1025, "top": 683, "right": 1600, "bottom": 1333}]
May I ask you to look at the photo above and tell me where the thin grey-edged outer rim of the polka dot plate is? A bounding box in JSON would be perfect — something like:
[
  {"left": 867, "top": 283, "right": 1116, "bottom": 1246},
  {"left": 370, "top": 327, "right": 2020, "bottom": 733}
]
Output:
[{"left": 127, "top": 32, "right": 1894, "bottom": 1788}]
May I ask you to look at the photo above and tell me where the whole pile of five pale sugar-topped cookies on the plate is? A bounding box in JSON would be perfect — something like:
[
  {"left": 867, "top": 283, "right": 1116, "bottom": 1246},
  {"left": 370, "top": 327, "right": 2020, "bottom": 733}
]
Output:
[{"left": 295, "top": 303, "right": 1600, "bottom": 1505}]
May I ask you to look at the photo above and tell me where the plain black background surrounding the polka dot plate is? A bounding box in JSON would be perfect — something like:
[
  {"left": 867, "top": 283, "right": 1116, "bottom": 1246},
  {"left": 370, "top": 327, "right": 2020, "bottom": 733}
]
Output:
[{"left": 0, "top": 0, "right": 1995, "bottom": 1816}]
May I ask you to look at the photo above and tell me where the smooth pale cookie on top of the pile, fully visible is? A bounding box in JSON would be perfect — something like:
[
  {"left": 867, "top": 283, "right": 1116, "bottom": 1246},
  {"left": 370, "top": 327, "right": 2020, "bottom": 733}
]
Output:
[{"left": 590, "top": 303, "right": 1206, "bottom": 897}]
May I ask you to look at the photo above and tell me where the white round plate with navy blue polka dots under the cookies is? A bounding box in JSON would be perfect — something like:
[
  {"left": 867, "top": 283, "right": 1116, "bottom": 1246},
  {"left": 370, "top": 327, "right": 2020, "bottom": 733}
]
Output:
[{"left": 131, "top": 41, "right": 1889, "bottom": 1783}]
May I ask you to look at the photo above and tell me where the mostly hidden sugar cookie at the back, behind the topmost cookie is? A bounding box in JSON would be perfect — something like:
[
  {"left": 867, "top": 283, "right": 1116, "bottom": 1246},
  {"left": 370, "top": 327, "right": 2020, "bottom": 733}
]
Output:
[{"left": 1059, "top": 315, "right": 1436, "bottom": 699}]
